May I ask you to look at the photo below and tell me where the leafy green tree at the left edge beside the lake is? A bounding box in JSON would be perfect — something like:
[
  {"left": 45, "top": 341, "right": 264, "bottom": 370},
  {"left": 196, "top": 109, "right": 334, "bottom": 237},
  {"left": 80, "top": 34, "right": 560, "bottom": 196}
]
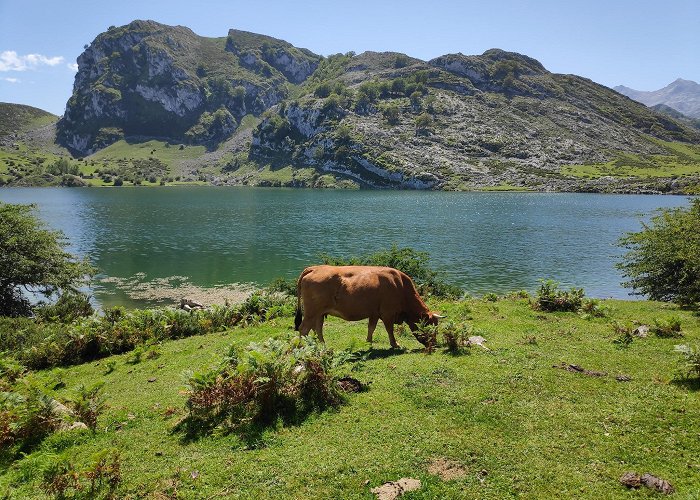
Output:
[{"left": 0, "top": 203, "right": 94, "bottom": 316}]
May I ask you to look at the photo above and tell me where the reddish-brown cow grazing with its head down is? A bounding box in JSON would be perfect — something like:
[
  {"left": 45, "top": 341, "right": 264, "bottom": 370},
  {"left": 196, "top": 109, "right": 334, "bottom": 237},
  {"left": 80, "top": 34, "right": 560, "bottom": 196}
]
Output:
[{"left": 294, "top": 265, "right": 442, "bottom": 348}]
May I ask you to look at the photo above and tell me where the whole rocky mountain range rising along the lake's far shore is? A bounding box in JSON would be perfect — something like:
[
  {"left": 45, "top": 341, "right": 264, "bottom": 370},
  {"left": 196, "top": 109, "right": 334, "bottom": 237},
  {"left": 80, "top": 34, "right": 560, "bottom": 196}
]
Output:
[{"left": 28, "top": 21, "right": 700, "bottom": 192}]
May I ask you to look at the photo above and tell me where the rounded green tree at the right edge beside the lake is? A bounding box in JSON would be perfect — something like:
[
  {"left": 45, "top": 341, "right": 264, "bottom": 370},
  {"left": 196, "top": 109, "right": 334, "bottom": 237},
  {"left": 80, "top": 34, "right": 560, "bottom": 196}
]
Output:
[{"left": 617, "top": 199, "right": 700, "bottom": 307}]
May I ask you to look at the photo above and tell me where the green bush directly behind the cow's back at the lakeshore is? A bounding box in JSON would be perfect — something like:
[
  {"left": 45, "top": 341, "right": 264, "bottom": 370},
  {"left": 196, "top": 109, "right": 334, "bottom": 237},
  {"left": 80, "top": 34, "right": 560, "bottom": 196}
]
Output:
[{"left": 320, "top": 245, "right": 463, "bottom": 298}]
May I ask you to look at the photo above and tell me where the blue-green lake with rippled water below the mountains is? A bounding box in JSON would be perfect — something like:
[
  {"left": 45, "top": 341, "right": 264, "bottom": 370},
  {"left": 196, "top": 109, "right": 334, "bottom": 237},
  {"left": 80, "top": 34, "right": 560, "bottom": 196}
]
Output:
[{"left": 0, "top": 186, "right": 688, "bottom": 306}]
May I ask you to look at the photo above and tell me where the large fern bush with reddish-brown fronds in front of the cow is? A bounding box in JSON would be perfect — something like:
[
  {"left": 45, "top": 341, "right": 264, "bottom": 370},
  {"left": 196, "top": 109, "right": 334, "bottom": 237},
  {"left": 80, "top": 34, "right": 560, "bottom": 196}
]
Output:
[{"left": 179, "top": 337, "right": 342, "bottom": 435}]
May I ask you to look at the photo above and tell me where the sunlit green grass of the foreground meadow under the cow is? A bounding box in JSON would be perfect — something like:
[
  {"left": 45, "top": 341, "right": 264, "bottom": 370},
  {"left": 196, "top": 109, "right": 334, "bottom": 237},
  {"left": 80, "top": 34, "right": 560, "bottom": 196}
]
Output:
[{"left": 0, "top": 299, "right": 700, "bottom": 499}]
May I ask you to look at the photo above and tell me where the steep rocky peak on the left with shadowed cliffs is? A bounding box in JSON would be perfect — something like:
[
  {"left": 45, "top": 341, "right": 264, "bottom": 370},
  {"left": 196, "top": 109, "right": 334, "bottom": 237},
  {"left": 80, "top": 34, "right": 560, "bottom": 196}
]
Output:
[{"left": 58, "top": 21, "right": 320, "bottom": 154}]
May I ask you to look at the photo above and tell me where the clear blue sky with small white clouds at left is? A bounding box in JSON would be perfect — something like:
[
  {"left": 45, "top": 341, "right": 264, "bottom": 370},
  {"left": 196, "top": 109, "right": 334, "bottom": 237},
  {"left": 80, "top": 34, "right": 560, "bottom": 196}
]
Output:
[{"left": 0, "top": 0, "right": 700, "bottom": 115}]
